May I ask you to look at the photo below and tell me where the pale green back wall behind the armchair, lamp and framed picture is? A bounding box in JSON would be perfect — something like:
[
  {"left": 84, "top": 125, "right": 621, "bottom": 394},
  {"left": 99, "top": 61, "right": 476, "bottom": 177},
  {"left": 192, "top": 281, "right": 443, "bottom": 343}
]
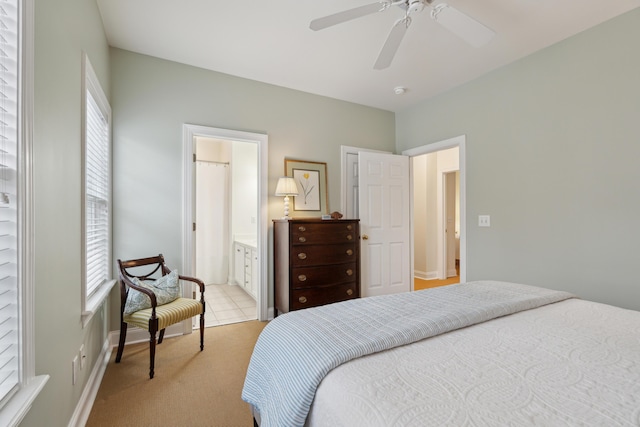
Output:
[{"left": 110, "top": 49, "right": 395, "bottom": 331}]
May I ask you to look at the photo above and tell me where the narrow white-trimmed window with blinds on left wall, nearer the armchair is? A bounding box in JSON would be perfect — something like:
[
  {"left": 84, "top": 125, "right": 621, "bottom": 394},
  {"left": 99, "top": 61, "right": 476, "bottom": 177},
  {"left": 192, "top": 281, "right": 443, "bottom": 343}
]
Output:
[{"left": 82, "top": 55, "right": 115, "bottom": 323}]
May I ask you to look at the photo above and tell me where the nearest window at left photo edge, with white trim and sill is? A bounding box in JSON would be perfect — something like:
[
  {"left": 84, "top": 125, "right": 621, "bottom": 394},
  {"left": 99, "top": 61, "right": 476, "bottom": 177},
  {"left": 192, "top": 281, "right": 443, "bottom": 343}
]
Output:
[{"left": 0, "top": 0, "right": 49, "bottom": 426}]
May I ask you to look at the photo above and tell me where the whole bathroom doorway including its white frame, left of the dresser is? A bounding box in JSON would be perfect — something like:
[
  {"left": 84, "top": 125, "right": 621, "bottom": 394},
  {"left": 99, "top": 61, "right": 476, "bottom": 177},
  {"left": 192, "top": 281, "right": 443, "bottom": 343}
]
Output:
[{"left": 183, "top": 125, "right": 268, "bottom": 326}]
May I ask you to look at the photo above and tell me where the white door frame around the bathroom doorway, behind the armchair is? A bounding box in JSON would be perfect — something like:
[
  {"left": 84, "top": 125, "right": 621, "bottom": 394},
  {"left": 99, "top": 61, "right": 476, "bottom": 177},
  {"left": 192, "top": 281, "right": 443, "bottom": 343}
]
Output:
[{"left": 181, "top": 124, "right": 269, "bottom": 324}]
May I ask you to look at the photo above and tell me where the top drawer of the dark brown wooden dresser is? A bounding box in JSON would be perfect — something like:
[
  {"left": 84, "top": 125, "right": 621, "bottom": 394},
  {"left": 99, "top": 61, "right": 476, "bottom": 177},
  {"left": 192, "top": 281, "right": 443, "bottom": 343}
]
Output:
[{"left": 291, "top": 221, "right": 359, "bottom": 245}]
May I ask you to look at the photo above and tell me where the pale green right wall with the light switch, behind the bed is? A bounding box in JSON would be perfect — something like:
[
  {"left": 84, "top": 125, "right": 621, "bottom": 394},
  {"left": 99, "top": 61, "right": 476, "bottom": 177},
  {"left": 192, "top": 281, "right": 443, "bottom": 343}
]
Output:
[{"left": 396, "top": 9, "right": 640, "bottom": 309}]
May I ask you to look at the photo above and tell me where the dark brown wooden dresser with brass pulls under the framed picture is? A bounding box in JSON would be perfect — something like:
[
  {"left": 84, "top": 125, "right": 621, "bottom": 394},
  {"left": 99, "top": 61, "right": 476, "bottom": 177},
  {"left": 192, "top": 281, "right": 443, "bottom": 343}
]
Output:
[{"left": 273, "top": 218, "right": 360, "bottom": 315}]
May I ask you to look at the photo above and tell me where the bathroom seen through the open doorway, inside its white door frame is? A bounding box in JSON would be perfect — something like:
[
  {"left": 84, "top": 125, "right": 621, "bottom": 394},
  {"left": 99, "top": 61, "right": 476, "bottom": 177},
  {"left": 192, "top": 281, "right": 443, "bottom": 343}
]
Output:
[{"left": 194, "top": 136, "right": 258, "bottom": 327}]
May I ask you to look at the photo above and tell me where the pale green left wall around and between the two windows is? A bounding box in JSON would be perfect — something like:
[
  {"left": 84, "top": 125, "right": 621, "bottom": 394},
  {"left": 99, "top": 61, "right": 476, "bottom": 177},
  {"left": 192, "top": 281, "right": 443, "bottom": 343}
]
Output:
[{"left": 21, "top": 0, "right": 110, "bottom": 427}]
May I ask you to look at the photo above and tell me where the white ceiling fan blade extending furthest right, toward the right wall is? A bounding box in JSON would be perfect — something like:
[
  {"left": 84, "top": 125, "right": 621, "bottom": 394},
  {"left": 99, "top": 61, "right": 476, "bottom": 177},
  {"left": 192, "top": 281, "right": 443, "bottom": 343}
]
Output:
[{"left": 431, "top": 3, "right": 496, "bottom": 47}]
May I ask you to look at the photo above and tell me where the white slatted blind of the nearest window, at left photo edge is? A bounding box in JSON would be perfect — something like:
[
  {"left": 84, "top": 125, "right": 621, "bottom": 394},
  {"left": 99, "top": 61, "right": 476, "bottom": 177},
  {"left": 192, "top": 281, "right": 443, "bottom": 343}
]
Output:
[{"left": 0, "top": 0, "right": 20, "bottom": 406}]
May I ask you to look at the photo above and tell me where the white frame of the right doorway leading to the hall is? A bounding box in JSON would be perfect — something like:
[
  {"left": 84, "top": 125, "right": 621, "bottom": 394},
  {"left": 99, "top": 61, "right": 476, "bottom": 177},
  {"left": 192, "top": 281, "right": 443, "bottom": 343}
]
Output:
[{"left": 402, "top": 135, "right": 467, "bottom": 289}]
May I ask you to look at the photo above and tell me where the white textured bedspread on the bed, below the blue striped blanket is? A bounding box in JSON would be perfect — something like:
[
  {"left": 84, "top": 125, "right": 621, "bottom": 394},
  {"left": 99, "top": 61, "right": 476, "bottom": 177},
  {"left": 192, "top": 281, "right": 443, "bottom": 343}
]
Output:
[{"left": 307, "top": 299, "right": 640, "bottom": 427}]
